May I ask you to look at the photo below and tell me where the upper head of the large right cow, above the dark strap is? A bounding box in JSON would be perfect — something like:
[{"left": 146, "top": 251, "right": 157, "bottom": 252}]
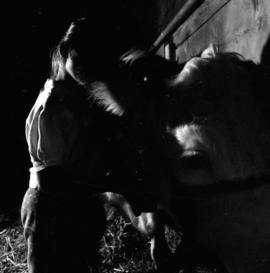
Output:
[{"left": 161, "top": 48, "right": 270, "bottom": 186}]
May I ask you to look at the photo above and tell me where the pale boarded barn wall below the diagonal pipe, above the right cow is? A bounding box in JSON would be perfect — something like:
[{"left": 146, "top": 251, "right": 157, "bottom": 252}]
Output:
[{"left": 169, "top": 0, "right": 270, "bottom": 62}]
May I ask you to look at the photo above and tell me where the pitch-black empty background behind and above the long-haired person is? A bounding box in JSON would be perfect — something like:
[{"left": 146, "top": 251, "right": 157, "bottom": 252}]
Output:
[{"left": 0, "top": 0, "right": 157, "bottom": 213}]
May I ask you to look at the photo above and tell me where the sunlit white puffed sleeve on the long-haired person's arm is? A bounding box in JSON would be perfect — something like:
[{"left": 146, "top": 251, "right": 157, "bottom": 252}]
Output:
[{"left": 26, "top": 82, "right": 74, "bottom": 172}]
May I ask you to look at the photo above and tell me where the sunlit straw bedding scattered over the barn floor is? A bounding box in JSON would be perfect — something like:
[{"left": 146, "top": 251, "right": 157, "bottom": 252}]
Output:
[{"left": 0, "top": 206, "right": 213, "bottom": 273}]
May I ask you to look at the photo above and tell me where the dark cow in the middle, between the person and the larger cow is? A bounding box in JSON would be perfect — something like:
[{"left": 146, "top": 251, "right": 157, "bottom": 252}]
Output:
[{"left": 85, "top": 49, "right": 182, "bottom": 267}]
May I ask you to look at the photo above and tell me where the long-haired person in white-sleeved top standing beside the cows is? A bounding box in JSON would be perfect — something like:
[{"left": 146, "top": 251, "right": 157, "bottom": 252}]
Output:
[{"left": 21, "top": 19, "right": 134, "bottom": 273}]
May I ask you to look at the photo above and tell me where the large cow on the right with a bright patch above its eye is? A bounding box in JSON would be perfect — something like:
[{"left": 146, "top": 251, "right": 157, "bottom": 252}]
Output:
[{"left": 94, "top": 44, "right": 270, "bottom": 273}]
